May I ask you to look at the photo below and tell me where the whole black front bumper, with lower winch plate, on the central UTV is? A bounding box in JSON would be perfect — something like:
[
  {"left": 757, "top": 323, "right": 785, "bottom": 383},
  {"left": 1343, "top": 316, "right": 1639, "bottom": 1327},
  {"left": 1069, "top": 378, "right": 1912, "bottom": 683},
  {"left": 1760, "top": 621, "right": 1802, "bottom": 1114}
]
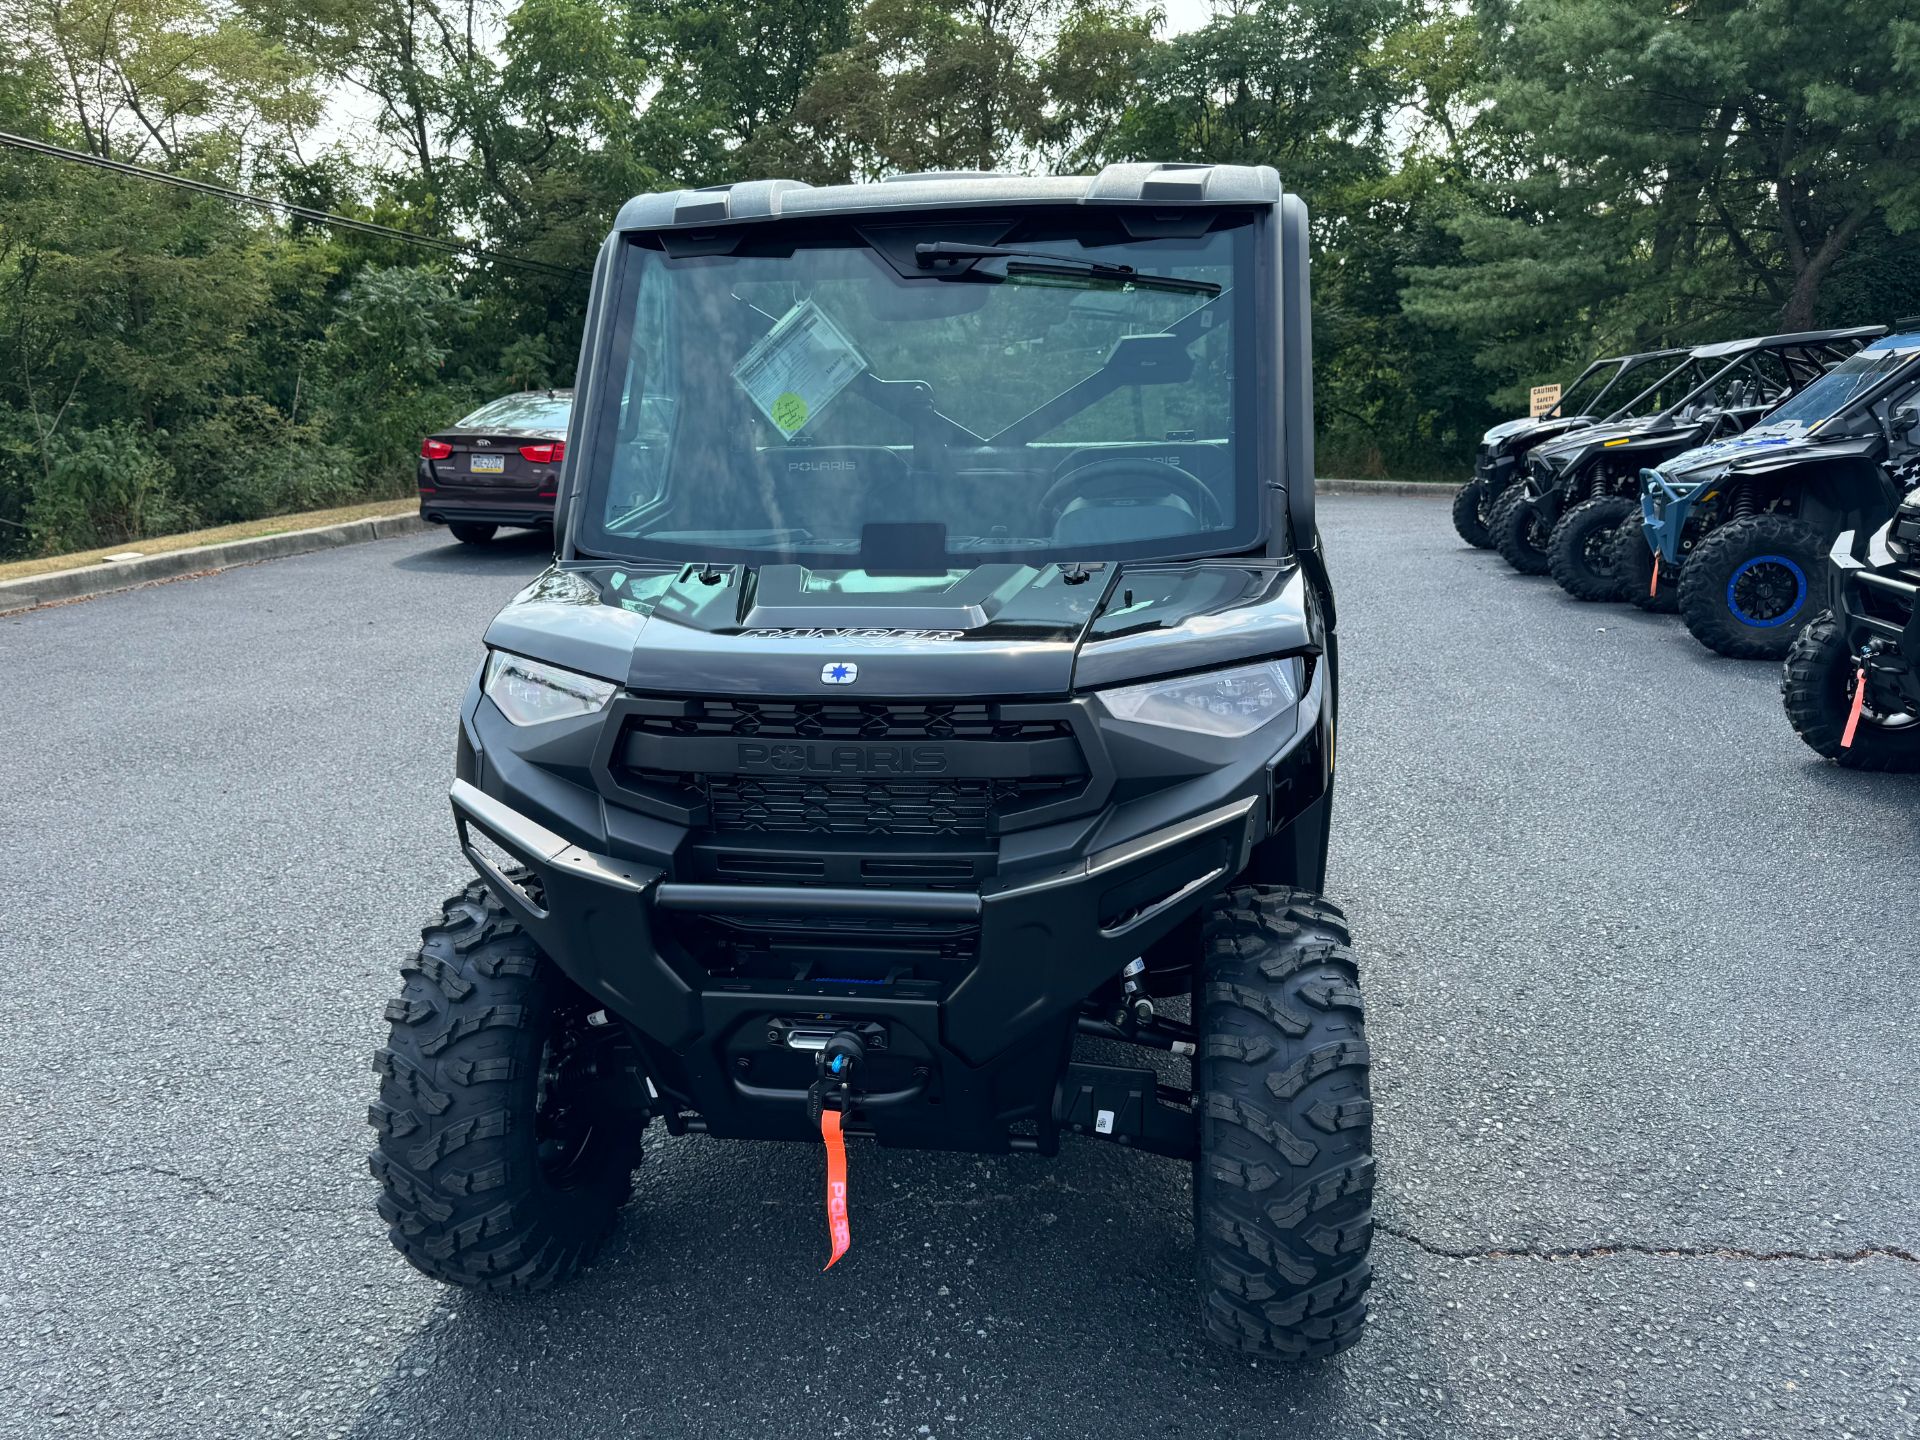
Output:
[{"left": 451, "top": 780, "right": 1265, "bottom": 1150}]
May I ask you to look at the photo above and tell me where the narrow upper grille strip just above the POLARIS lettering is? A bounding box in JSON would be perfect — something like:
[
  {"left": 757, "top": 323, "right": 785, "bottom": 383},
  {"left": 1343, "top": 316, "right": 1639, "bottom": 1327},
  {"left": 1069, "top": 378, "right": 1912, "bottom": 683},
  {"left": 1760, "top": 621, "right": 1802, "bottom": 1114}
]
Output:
[{"left": 628, "top": 701, "right": 1073, "bottom": 741}]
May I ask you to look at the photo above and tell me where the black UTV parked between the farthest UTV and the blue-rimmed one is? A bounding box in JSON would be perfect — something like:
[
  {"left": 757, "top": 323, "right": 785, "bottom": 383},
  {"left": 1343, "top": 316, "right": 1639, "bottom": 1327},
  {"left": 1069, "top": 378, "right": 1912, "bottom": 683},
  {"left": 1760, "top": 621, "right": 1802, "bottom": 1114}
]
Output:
[{"left": 1492, "top": 324, "right": 1887, "bottom": 601}]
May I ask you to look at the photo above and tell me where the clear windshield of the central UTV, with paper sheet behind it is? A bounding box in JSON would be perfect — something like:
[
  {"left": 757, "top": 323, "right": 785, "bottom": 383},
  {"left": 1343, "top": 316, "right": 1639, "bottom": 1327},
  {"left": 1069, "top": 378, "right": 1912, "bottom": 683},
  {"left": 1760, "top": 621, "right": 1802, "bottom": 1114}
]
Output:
[{"left": 576, "top": 211, "right": 1261, "bottom": 568}]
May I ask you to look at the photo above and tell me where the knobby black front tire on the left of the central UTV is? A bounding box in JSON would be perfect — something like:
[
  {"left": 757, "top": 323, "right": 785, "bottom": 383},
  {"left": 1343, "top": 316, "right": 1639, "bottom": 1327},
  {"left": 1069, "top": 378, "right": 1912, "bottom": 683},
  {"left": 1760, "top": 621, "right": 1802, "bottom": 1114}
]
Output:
[{"left": 367, "top": 881, "right": 645, "bottom": 1290}]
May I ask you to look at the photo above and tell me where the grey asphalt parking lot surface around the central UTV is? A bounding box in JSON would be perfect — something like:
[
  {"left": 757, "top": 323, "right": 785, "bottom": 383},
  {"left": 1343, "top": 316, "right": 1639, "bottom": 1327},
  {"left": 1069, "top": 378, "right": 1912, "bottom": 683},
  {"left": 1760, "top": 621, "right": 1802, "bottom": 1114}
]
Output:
[{"left": 0, "top": 497, "right": 1920, "bottom": 1440}]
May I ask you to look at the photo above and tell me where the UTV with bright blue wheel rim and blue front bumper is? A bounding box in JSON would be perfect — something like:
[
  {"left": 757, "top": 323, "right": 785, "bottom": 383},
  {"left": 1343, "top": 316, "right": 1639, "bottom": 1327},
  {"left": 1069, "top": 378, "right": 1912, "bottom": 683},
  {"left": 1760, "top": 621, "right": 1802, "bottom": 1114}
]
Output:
[{"left": 1613, "top": 332, "right": 1920, "bottom": 660}]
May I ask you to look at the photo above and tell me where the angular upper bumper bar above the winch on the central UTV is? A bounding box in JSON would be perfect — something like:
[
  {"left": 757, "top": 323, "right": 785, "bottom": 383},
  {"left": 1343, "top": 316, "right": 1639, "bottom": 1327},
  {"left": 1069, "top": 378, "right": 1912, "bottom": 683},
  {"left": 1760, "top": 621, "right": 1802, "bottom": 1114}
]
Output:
[{"left": 449, "top": 780, "right": 1265, "bottom": 1068}]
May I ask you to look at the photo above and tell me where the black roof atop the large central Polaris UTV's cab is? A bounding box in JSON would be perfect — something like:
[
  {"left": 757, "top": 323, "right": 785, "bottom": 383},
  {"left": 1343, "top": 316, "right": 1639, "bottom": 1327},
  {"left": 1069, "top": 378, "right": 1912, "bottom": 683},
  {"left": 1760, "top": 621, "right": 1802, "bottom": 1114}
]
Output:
[{"left": 614, "top": 163, "right": 1281, "bottom": 230}]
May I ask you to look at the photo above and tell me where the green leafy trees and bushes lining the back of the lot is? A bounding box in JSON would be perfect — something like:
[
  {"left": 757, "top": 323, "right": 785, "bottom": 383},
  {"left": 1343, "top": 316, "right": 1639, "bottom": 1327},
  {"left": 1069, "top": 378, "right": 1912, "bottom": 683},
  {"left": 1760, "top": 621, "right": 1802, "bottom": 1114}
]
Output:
[{"left": 0, "top": 0, "right": 1920, "bottom": 553}]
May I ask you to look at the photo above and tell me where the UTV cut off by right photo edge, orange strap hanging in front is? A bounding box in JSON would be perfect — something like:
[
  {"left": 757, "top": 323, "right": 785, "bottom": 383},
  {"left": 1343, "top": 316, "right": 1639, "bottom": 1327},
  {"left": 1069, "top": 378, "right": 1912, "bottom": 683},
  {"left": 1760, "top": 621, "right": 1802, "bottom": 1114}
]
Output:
[{"left": 1780, "top": 474, "right": 1920, "bottom": 772}]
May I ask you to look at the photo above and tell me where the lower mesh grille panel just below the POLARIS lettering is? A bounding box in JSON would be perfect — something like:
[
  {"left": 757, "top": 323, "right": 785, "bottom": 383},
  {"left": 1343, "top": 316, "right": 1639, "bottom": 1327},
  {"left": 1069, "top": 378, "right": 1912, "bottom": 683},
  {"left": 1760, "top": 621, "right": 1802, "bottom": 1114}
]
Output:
[{"left": 634, "top": 770, "right": 1085, "bottom": 839}]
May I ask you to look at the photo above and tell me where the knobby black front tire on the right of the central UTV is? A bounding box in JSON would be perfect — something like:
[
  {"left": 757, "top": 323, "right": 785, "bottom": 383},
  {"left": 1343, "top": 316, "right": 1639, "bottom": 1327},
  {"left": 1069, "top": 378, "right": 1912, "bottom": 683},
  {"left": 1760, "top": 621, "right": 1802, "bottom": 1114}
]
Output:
[{"left": 1194, "top": 887, "right": 1373, "bottom": 1359}]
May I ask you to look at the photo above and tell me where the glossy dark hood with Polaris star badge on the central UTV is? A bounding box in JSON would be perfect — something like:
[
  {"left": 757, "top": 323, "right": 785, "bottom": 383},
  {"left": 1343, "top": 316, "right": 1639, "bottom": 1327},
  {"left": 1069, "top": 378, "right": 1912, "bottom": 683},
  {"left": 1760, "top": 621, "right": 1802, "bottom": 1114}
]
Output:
[{"left": 486, "top": 561, "right": 1309, "bottom": 701}]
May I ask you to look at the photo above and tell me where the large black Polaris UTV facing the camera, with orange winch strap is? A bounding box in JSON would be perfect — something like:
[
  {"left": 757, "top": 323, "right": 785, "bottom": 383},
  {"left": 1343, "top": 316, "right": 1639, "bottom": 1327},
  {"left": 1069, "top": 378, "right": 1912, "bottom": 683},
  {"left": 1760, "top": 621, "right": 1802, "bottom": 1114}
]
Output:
[{"left": 372, "top": 165, "right": 1373, "bottom": 1356}]
